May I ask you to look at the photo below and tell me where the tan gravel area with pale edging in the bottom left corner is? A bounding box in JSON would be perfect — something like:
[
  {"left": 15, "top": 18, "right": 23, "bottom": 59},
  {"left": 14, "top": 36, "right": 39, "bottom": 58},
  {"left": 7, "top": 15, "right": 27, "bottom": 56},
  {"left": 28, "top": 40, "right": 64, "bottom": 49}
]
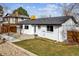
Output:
[{"left": 0, "top": 40, "right": 37, "bottom": 56}]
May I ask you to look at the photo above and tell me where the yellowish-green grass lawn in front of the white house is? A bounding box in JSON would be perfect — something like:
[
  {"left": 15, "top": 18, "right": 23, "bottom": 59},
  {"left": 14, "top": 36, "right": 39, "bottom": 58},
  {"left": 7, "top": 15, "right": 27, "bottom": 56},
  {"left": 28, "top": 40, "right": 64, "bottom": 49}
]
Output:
[{"left": 14, "top": 38, "right": 79, "bottom": 56}]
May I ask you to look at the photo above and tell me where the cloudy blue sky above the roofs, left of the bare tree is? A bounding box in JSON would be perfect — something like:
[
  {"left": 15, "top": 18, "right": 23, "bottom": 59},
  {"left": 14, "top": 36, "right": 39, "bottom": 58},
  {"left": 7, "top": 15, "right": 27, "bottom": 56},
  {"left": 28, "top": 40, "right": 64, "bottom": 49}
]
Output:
[{"left": 0, "top": 3, "right": 62, "bottom": 17}]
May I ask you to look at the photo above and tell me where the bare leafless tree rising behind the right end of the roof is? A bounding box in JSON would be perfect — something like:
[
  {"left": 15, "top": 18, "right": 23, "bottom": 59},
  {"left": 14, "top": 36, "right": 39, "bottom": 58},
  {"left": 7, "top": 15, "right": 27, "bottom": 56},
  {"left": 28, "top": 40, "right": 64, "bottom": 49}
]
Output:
[{"left": 62, "top": 3, "right": 79, "bottom": 22}]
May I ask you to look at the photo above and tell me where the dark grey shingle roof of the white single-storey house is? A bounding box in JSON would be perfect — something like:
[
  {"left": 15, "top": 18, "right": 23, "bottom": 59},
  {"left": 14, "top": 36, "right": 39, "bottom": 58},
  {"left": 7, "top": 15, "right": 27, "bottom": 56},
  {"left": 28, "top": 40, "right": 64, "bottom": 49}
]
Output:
[{"left": 19, "top": 16, "right": 77, "bottom": 25}]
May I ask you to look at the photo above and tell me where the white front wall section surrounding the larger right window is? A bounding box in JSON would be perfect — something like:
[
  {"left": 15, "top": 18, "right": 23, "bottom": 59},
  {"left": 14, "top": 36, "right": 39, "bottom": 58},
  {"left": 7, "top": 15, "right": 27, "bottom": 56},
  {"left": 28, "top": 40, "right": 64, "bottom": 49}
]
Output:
[{"left": 37, "top": 25, "right": 59, "bottom": 40}]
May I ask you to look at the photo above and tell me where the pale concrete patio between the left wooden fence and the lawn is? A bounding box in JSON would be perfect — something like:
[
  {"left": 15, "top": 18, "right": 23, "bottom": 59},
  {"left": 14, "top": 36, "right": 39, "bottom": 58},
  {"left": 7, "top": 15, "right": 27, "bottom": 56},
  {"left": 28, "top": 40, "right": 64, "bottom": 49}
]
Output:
[{"left": 0, "top": 33, "right": 34, "bottom": 42}]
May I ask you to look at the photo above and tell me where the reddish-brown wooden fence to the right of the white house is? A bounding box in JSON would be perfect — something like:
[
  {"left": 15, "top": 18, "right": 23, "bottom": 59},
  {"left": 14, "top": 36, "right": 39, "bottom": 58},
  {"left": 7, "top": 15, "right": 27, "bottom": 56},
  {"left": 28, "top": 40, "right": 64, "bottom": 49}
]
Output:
[{"left": 67, "top": 31, "right": 79, "bottom": 43}]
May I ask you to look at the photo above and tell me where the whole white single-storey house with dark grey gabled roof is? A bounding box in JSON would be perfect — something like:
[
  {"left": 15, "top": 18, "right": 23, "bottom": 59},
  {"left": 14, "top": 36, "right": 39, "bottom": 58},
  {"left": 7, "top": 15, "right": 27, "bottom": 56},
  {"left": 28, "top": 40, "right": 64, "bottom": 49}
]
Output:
[{"left": 19, "top": 16, "right": 77, "bottom": 41}]
